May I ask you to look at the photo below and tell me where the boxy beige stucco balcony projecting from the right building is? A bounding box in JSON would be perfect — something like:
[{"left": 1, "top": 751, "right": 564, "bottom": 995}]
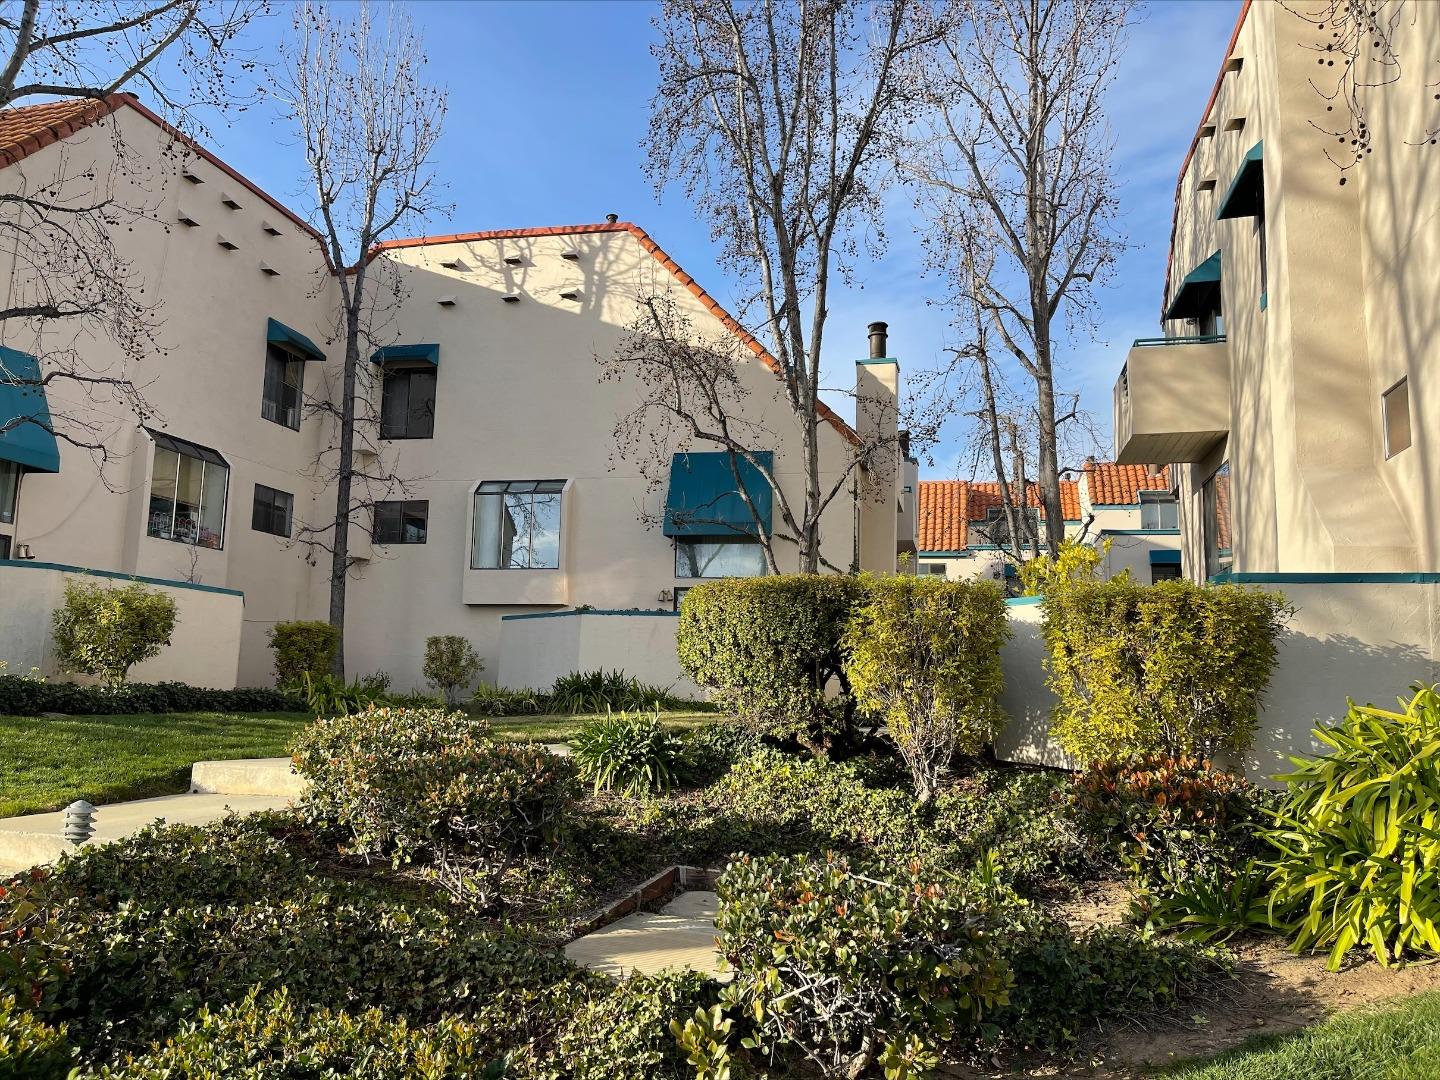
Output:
[{"left": 1115, "top": 336, "right": 1230, "bottom": 465}]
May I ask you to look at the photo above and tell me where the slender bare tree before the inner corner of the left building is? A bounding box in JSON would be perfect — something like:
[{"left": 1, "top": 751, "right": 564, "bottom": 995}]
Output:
[{"left": 278, "top": 3, "right": 446, "bottom": 675}]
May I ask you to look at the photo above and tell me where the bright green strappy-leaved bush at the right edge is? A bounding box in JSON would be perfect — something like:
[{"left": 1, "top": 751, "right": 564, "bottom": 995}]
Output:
[{"left": 1266, "top": 687, "right": 1440, "bottom": 971}]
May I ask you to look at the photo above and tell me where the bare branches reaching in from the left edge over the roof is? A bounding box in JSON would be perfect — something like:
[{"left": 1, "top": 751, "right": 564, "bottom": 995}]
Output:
[{"left": 0, "top": 0, "right": 264, "bottom": 469}]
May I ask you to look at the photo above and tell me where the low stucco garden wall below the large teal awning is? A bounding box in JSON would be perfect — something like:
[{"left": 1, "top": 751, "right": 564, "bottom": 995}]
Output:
[{"left": 495, "top": 611, "right": 706, "bottom": 698}]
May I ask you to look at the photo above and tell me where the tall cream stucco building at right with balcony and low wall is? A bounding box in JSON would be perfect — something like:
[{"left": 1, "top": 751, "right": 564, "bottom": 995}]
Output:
[{"left": 1115, "top": 3, "right": 1440, "bottom": 773}]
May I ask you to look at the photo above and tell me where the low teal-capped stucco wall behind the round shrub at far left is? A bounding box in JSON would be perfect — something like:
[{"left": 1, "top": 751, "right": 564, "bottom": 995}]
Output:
[{"left": 0, "top": 560, "right": 245, "bottom": 690}]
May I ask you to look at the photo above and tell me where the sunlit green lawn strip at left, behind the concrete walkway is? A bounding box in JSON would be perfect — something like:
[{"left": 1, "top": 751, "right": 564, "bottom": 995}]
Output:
[{"left": 0, "top": 713, "right": 310, "bottom": 816}]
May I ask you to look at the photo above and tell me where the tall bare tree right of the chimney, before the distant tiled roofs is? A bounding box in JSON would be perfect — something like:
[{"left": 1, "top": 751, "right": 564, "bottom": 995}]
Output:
[{"left": 899, "top": 0, "right": 1132, "bottom": 553}]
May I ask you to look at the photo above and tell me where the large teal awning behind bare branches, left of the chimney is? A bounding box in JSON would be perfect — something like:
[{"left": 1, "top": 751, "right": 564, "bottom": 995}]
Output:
[{"left": 662, "top": 451, "right": 775, "bottom": 539}]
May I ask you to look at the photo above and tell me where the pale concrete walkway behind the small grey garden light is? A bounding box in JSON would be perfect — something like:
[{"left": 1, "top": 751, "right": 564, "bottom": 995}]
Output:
[{"left": 0, "top": 795, "right": 291, "bottom": 876}]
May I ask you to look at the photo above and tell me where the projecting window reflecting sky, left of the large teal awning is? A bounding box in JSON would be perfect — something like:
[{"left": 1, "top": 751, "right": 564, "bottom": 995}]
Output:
[{"left": 469, "top": 480, "right": 564, "bottom": 570}]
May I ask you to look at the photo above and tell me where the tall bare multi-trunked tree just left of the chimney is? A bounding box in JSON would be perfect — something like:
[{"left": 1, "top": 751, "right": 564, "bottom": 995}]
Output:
[{"left": 647, "top": 0, "right": 933, "bottom": 572}]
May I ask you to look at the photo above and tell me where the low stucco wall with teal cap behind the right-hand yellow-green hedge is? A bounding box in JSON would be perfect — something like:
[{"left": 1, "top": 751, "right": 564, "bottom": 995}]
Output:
[{"left": 995, "top": 575, "right": 1440, "bottom": 782}]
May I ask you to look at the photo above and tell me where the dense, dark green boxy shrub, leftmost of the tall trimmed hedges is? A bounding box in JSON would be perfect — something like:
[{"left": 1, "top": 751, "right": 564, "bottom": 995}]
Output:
[{"left": 675, "top": 575, "right": 861, "bottom": 753}]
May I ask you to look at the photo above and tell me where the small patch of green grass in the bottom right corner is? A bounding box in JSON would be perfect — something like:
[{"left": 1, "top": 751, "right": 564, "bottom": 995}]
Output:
[{"left": 1156, "top": 992, "right": 1440, "bottom": 1080}]
